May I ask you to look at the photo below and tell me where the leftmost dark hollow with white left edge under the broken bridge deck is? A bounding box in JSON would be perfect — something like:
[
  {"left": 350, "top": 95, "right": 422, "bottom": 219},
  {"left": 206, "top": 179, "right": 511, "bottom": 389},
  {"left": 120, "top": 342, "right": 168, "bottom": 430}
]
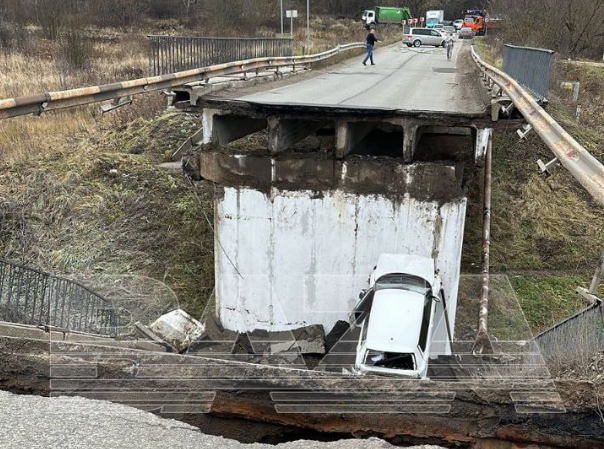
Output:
[{"left": 202, "top": 109, "right": 267, "bottom": 145}]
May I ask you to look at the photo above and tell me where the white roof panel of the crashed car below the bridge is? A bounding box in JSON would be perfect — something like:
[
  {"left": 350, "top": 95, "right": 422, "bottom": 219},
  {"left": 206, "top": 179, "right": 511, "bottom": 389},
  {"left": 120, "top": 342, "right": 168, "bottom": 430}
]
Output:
[{"left": 365, "top": 290, "right": 425, "bottom": 353}]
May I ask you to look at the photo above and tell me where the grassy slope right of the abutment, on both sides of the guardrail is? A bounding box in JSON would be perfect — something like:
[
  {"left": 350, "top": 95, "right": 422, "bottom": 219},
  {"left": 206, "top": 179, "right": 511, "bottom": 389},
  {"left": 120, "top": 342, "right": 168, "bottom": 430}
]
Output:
[{"left": 464, "top": 40, "right": 604, "bottom": 331}]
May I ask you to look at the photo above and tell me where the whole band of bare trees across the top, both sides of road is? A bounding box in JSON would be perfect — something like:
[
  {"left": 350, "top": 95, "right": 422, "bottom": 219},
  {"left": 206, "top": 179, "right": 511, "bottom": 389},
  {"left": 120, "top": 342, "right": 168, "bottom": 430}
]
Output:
[{"left": 0, "top": 0, "right": 604, "bottom": 57}]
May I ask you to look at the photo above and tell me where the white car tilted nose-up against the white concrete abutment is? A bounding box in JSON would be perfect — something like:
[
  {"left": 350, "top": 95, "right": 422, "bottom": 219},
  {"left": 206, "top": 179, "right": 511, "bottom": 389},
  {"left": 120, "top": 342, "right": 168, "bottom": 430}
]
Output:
[{"left": 351, "top": 254, "right": 442, "bottom": 379}]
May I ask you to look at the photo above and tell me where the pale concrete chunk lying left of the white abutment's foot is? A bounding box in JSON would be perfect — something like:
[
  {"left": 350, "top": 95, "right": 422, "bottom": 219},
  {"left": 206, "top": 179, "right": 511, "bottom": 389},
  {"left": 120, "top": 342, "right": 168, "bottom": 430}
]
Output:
[{"left": 149, "top": 309, "right": 205, "bottom": 352}]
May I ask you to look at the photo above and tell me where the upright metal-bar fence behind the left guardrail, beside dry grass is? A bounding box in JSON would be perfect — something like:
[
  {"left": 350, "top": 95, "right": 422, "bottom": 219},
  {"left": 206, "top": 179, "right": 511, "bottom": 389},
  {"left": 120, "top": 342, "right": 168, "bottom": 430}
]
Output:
[{"left": 148, "top": 36, "right": 294, "bottom": 76}]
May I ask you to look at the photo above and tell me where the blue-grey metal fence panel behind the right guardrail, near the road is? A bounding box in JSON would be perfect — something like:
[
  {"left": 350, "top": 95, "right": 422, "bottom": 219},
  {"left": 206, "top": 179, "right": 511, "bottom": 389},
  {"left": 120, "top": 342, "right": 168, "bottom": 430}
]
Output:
[{"left": 503, "top": 45, "right": 554, "bottom": 102}]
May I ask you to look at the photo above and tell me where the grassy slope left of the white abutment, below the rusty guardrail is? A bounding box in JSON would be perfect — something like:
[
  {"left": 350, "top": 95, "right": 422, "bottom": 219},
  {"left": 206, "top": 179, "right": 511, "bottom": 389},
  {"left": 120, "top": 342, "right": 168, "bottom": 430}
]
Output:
[{"left": 0, "top": 110, "right": 214, "bottom": 315}]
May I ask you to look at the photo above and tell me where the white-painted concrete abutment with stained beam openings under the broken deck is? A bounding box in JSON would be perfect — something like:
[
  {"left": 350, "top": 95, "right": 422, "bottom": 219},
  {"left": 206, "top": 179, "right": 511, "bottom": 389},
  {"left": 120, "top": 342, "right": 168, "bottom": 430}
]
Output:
[{"left": 189, "top": 102, "right": 492, "bottom": 353}]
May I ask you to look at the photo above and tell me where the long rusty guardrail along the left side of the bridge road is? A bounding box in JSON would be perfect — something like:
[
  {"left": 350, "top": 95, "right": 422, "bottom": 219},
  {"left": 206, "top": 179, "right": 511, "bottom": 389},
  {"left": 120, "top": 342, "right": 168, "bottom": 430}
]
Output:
[{"left": 0, "top": 42, "right": 365, "bottom": 119}]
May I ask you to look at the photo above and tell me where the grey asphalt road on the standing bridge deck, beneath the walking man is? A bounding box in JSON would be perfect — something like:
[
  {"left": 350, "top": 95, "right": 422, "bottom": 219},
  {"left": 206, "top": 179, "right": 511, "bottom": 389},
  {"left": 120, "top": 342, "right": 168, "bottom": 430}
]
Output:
[{"left": 236, "top": 43, "right": 488, "bottom": 115}]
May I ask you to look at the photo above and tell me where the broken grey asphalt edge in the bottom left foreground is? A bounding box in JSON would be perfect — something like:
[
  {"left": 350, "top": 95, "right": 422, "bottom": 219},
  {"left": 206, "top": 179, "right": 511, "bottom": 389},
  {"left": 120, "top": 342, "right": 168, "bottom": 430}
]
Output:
[{"left": 0, "top": 391, "right": 446, "bottom": 449}]
